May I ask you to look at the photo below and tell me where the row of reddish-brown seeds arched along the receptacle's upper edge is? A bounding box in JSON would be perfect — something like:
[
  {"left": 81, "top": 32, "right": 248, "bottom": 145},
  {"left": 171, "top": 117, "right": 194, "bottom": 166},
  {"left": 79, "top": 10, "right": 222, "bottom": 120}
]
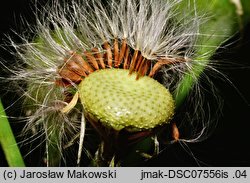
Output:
[{"left": 56, "top": 39, "right": 187, "bottom": 86}]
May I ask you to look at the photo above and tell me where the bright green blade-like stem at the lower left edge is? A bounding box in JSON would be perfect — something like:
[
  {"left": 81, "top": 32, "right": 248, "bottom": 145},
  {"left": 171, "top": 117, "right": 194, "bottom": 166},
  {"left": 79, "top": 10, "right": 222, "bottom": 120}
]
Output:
[{"left": 0, "top": 100, "right": 25, "bottom": 167}]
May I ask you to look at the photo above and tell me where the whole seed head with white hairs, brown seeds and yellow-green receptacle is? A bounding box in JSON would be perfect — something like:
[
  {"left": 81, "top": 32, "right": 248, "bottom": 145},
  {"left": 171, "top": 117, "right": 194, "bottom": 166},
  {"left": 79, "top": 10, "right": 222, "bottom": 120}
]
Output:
[{"left": 1, "top": 0, "right": 211, "bottom": 166}]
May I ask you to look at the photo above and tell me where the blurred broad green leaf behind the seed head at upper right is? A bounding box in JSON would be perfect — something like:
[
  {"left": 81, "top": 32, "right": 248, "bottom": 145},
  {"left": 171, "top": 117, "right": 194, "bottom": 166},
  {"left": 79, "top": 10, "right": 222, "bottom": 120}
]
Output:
[{"left": 175, "top": 0, "right": 247, "bottom": 107}]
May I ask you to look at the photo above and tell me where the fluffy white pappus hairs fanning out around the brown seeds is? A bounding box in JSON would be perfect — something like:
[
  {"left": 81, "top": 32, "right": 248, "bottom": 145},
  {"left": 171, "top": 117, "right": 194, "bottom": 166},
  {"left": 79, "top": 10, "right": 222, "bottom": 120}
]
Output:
[{"left": 0, "top": 0, "right": 224, "bottom": 166}]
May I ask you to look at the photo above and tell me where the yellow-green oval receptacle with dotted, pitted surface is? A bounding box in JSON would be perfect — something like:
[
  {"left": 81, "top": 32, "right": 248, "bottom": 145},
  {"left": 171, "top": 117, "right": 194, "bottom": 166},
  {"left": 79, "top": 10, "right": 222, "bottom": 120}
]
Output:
[{"left": 79, "top": 69, "right": 174, "bottom": 131}]
